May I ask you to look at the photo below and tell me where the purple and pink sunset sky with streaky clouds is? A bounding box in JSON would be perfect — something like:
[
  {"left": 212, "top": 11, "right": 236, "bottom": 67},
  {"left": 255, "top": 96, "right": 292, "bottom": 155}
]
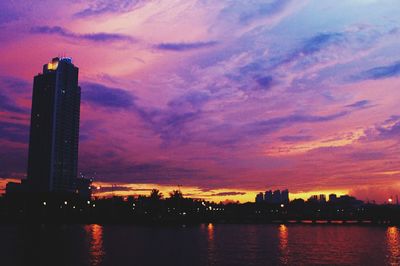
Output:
[{"left": 0, "top": 0, "right": 400, "bottom": 202}]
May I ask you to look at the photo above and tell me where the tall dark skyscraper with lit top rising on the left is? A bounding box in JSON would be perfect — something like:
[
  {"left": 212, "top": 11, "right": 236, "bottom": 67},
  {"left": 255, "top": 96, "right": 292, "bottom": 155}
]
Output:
[{"left": 28, "top": 57, "right": 81, "bottom": 192}]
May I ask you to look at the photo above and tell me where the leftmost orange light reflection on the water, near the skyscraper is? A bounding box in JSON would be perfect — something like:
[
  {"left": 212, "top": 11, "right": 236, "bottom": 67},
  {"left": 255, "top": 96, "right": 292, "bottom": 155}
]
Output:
[{"left": 85, "top": 224, "right": 105, "bottom": 266}]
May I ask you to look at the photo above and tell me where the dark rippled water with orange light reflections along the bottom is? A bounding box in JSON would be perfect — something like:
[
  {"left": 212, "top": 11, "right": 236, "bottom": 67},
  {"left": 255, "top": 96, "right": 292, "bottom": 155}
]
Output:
[{"left": 0, "top": 224, "right": 400, "bottom": 266}]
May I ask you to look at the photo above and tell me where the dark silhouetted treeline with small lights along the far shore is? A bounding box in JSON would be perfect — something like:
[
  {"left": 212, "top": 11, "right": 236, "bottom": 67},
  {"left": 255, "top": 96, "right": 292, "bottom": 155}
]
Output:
[{"left": 0, "top": 189, "right": 400, "bottom": 224}]
